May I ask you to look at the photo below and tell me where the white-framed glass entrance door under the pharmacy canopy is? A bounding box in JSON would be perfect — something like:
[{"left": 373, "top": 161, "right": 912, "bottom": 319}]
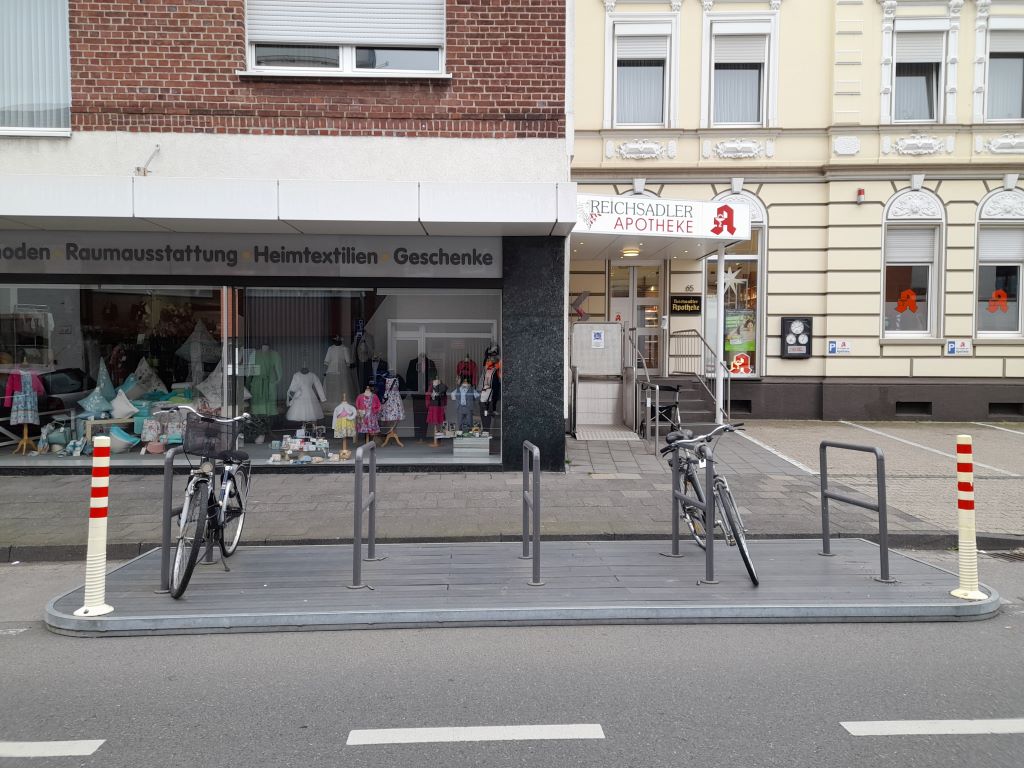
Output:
[{"left": 608, "top": 263, "right": 664, "bottom": 376}]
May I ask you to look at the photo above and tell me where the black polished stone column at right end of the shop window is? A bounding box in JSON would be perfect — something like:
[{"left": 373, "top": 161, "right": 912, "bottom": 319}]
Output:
[{"left": 501, "top": 238, "right": 565, "bottom": 472}]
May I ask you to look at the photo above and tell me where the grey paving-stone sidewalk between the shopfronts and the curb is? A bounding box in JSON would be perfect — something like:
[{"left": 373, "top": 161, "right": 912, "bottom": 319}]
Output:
[{"left": 6, "top": 428, "right": 1007, "bottom": 561}]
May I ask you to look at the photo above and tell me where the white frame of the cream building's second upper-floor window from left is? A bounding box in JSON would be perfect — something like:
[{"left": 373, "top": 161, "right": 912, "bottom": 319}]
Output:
[{"left": 700, "top": 10, "right": 779, "bottom": 128}]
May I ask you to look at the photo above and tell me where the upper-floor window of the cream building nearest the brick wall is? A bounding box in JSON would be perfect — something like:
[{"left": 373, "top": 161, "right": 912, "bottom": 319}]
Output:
[{"left": 614, "top": 24, "right": 671, "bottom": 126}]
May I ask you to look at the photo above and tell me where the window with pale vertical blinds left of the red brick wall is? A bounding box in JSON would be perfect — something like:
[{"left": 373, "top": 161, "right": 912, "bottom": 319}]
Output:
[{"left": 0, "top": 0, "right": 71, "bottom": 135}]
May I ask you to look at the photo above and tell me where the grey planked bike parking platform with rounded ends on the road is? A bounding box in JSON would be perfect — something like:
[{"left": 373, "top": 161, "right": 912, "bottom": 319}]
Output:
[{"left": 45, "top": 539, "right": 999, "bottom": 636}]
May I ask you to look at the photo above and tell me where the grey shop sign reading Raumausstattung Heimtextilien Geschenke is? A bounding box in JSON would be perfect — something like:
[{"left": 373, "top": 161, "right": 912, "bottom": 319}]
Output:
[{"left": 0, "top": 230, "right": 502, "bottom": 279}]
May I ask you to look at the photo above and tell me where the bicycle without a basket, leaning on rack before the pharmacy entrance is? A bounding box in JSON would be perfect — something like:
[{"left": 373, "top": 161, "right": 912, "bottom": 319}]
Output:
[{"left": 660, "top": 424, "right": 759, "bottom": 586}]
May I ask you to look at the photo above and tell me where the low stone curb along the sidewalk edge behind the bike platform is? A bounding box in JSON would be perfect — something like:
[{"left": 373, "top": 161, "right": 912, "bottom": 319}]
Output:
[{"left": 9, "top": 531, "right": 1024, "bottom": 562}]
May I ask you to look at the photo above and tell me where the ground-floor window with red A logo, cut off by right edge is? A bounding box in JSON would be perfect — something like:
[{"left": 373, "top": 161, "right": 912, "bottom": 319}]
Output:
[{"left": 976, "top": 226, "right": 1024, "bottom": 335}]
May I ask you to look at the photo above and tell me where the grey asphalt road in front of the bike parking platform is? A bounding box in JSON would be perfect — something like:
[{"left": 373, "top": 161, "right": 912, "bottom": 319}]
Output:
[{"left": 0, "top": 552, "right": 1024, "bottom": 768}]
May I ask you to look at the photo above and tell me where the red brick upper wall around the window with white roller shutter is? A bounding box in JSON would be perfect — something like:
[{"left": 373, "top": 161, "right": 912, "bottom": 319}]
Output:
[{"left": 70, "top": 0, "right": 565, "bottom": 138}]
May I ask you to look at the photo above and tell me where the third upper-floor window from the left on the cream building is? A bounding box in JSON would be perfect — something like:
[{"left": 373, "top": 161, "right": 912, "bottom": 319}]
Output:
[{"left": 893, "top": 31, "right": 946, "bottom": 123}]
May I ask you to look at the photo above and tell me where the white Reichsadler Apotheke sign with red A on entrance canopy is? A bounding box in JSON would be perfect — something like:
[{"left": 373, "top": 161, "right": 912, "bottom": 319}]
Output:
[{"left": 572, "top": 195, "right": 751, "bottom": 240}]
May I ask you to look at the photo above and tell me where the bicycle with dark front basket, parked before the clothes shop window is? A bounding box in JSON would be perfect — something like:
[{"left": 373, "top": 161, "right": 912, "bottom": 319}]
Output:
[{"left": 168, "top": 406, "right": 252, "bottom": 599}]
